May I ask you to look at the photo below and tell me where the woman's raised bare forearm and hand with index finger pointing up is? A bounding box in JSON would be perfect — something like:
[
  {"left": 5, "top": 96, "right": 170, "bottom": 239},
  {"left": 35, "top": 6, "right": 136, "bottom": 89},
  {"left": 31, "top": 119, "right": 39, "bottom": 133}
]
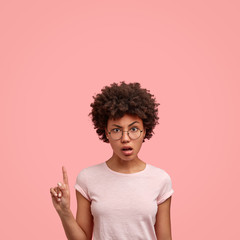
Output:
[{"left": 50, "top": 167, "right": 91, "bottom": 240}]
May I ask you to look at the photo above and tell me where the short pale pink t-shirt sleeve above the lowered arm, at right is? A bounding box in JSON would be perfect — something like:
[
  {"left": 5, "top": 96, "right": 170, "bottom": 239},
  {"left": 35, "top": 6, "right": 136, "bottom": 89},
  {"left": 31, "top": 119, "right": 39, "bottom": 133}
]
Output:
[{"left": 157, "top": 172, "right": 174, "bottom": 204}]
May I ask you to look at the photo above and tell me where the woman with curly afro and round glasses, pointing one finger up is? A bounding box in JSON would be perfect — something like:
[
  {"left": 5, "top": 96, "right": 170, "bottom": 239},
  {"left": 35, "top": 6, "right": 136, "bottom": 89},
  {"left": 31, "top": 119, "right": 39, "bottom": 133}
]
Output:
[{"left": 50, "top": 82, "right": 174, "bottom": 240}]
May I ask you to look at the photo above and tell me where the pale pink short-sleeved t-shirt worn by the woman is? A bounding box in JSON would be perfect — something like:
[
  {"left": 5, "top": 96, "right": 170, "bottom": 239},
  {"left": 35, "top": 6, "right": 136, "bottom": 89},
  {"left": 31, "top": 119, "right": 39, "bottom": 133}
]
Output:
[{"left": 75, "top": 162, "right": 174, "bottom": 240}]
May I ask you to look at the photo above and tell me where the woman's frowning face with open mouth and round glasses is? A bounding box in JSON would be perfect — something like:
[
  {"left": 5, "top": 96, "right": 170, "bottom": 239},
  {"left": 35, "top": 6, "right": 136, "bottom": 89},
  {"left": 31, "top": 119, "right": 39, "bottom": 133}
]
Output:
[{"left": 106, "top": 114, "right": 146, "bottom": 161}]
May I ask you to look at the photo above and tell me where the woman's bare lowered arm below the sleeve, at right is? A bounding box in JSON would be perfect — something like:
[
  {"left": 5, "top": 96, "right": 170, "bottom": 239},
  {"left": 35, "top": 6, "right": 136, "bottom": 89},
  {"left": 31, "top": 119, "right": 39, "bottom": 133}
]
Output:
[{"left": 154, "top": 197, "right": 172, "bottom": 240}]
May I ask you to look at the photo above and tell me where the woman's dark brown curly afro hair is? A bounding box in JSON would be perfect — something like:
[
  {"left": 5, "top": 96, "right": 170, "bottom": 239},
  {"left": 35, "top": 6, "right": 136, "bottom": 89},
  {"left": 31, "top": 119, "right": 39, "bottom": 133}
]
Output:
[{"left": 89, "top": 81, "right": 160, "bottom": 143}]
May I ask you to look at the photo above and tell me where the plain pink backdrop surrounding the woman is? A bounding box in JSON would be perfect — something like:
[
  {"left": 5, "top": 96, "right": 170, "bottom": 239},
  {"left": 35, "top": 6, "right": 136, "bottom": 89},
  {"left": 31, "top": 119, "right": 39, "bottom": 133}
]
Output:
[{"left": 0, "top": 0, "right": 240, "bottom": 240}]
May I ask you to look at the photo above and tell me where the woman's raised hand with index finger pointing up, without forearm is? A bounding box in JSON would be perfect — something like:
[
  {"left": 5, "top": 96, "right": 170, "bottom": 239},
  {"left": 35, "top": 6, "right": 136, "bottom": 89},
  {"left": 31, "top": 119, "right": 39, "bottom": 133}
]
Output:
[{"left": 50, "top": 166, "right": 71, "bottom": 214}]
